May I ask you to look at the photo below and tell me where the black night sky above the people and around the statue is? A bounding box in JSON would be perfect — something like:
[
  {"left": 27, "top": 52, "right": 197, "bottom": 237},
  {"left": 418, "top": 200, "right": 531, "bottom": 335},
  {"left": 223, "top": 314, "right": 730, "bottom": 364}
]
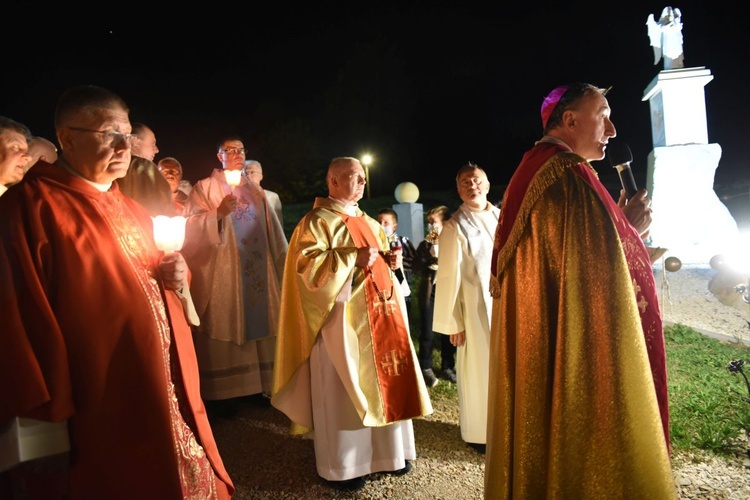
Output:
[{"left": 0, "top": 1, "right": 750, "bottom": 201}]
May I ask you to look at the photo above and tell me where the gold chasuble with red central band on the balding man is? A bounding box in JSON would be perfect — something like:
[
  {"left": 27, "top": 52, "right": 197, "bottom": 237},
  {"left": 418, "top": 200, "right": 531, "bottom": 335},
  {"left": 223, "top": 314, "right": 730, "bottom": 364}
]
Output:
[{"left": 271, "top": 198, "right": 432, "bottom": 434}]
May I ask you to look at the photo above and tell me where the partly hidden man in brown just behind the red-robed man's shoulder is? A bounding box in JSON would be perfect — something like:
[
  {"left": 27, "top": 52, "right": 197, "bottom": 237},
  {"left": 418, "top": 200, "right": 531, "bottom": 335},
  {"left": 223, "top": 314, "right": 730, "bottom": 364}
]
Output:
[{"left": 117, "top": 123, "right": 178, "bottom": 216}]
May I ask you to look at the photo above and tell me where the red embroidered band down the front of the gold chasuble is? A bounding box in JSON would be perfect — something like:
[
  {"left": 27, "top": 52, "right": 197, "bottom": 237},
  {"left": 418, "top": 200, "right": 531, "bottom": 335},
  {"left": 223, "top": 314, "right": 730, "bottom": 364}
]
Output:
[{"left": 341, "top": 214, "right": 421, "bottom": 423}]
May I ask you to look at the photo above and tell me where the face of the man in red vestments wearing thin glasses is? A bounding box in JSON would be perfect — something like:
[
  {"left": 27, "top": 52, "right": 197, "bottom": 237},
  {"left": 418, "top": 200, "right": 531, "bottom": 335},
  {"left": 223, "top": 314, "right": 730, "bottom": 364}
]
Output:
[{"left": 58, "top": 108, "right": 134, "bottom": 184}]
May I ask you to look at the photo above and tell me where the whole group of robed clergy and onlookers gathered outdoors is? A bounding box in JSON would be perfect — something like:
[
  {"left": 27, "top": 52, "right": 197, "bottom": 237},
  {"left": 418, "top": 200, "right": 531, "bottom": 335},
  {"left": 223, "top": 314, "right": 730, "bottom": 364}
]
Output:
[{"left": 0, "top": 83, "right": 675, "bottom": 499}]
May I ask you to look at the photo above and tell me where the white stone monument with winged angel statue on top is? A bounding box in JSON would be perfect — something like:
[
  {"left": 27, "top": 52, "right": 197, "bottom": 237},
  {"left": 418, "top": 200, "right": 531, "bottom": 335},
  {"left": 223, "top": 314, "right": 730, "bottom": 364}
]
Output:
[{"left": 642, "top": 7, "right": 739, "bottom": 264}]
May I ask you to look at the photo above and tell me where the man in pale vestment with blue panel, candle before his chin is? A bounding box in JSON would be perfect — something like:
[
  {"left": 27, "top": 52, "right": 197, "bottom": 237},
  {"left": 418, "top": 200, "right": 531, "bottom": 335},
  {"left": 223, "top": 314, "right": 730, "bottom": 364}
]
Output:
[{"left": 184, "top": 136, "right": 287, "bottom": 415}]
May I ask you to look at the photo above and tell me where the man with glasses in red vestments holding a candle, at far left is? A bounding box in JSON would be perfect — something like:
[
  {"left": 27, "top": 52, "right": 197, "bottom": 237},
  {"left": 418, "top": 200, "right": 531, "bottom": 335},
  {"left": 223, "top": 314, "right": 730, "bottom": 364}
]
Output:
[{"left": 0, "top": 85, "right": 234, "bottom": 499}]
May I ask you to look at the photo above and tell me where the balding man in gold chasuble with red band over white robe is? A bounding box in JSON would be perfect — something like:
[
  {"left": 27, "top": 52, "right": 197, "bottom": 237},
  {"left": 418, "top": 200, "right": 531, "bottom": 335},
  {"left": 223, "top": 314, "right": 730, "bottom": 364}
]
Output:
[{"left": 271, "top": 157, "right": 432, "bottom": 488}]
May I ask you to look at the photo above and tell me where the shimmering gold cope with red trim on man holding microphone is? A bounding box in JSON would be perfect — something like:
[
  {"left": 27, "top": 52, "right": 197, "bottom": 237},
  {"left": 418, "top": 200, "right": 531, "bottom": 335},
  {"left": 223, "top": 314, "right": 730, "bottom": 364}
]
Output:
[{"left": 485, "top": 142, "right": 676, "bottom": 500}]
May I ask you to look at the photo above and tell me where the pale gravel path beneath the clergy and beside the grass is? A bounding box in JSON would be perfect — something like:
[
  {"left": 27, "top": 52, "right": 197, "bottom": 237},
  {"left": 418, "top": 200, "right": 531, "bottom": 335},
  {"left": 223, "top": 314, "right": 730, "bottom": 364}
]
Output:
[{"left": 211, "top": 266, "right": 750, "bottom": 500}]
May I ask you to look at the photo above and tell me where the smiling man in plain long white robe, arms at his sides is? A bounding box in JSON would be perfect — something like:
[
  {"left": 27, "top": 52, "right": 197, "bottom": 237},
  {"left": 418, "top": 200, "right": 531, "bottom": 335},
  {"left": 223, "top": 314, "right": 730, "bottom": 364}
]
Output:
[{"left": 433, "top": 163, "right": 500, "bottom": 453}]
